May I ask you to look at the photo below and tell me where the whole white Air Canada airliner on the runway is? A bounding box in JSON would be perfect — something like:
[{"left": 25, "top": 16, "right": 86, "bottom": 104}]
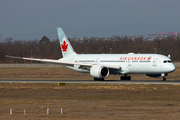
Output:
[{"left": 6, "top": 27, "right": 176, "bottom": 81}]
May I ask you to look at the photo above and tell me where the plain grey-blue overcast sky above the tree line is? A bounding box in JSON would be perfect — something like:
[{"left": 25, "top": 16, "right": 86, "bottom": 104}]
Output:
[{"left": 0, "top": 0, "right": 180, "bottom": 40}]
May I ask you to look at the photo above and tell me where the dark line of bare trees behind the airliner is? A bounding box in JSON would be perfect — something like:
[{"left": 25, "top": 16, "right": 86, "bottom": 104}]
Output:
[{"left": 0, "top": 36, "right": 180, "bottom": 63}]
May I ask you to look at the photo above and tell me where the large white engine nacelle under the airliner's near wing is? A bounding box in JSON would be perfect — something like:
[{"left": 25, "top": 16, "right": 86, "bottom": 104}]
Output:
[{"left": 90, "top": 65, "right": 109, "bottom": 78}]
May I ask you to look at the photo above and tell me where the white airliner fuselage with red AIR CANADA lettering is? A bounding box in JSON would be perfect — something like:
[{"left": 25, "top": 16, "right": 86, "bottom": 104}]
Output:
[{"left": 60, "top": 54, "right": 176, "bottom": 74}]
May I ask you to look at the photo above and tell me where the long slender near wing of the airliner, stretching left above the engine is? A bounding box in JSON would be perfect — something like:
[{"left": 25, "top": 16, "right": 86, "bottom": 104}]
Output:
[{"left": 6, "top": 55, "right": 121, "bottom": 70}]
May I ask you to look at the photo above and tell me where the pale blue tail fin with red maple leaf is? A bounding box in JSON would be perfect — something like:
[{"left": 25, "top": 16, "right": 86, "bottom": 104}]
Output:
[{"left": 57, "top": 27, "right": 76, "bottom": 57}]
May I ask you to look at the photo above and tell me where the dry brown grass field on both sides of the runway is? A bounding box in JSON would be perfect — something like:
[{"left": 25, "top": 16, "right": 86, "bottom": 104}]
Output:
[{"left": 0, "top": 68, "right": 180, "bottom": 120}]
